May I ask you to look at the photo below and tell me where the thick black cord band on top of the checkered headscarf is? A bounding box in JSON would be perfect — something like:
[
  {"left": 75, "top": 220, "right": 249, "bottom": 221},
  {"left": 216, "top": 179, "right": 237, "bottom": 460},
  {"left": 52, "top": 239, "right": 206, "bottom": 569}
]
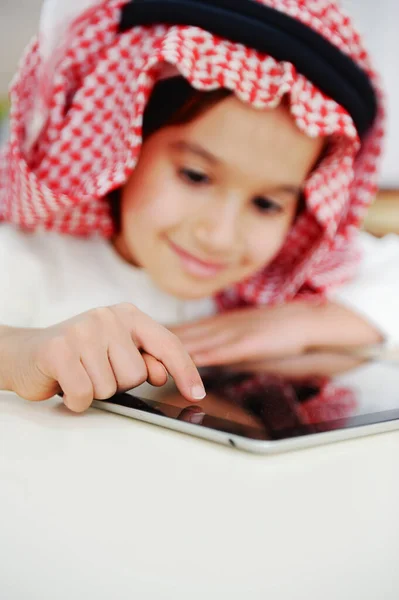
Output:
[{"left": 119, "top": 0, "right": 377, "bottom": 137}]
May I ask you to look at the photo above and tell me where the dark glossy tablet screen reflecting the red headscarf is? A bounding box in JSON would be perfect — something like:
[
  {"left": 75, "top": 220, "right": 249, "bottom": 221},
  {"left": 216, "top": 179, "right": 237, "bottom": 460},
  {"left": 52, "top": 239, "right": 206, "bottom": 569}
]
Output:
[{"left": 101, "top": 356, "right": 399, "bottom": 440}]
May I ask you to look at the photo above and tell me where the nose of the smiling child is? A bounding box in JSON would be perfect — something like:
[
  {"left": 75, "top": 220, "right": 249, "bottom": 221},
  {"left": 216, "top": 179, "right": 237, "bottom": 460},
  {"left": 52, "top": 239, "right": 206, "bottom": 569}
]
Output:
[{"left": 193, "top": 194, "right": 242, "bottom": 254}]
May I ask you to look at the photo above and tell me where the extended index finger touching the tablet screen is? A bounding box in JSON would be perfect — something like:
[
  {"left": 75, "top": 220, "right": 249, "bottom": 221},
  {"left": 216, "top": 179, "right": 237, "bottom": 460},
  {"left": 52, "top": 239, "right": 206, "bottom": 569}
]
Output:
[{"left": 124, "top": 313, "right": 206, "bottom": 402}]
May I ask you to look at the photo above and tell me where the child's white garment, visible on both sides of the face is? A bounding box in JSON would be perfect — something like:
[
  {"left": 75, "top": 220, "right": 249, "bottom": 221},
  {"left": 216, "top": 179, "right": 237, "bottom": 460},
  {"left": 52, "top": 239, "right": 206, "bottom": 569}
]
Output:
[{"left": 0, "top": 224, "right": 399, "bottom": 344}]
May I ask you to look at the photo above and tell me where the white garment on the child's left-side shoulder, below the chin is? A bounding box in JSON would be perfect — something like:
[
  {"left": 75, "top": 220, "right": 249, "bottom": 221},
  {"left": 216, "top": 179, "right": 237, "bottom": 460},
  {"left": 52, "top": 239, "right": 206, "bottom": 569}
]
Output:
[{"left": 0, "top": 224, "right": 216, "bottom": 327}]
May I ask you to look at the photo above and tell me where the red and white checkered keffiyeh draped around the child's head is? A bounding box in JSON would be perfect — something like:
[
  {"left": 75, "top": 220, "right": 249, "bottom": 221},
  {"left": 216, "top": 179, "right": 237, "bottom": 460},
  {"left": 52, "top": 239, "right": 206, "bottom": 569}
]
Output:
[{"left": 0, "top": 0, "right": 384, "bottom": 309}]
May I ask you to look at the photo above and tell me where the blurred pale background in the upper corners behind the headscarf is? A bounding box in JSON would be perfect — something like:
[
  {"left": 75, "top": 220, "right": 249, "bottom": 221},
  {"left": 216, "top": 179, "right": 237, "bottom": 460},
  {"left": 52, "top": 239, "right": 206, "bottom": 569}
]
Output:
[{"left": 0, "top": 0, "right": 399, "bottom": 235}]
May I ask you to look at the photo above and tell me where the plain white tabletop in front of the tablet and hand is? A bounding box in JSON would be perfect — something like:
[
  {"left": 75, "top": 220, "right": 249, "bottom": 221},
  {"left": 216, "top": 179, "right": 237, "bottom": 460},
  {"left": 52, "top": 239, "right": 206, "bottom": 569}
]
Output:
[{"left": 0, "top": 393, "right": 399, "bottom": 600}]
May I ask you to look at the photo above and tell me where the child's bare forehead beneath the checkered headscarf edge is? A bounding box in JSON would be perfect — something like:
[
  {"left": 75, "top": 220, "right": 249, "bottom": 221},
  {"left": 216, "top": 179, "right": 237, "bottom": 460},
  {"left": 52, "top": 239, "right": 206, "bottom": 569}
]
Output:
[{"left": 169, "top": 96, "right": 323, "bottom": 182}]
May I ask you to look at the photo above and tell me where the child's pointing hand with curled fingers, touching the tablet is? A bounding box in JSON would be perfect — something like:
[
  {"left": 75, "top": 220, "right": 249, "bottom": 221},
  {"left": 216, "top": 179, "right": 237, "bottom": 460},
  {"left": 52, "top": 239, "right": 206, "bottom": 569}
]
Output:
[{"left": 2, "top": 304, "right": 205, "bottom": 412}]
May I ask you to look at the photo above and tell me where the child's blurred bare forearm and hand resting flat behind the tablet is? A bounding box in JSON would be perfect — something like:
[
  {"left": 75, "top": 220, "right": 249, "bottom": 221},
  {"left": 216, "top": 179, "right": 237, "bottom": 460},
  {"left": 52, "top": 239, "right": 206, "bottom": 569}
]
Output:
[{"left": 171, "top": 300, "right": 383, "bottom": 368}]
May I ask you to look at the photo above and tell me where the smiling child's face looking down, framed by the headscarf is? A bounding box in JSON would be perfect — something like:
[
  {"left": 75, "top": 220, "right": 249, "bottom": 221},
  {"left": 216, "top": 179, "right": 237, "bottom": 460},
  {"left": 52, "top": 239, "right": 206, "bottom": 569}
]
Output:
[{"left": 115, "top": 96, "right": 323, "bottom": 299}]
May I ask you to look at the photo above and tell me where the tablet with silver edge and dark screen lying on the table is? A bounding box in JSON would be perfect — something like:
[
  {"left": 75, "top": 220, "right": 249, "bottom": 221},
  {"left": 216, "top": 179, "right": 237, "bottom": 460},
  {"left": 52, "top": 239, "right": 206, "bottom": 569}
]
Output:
[{"left": 93, "top": 360, "right": 399, "bottom": 453}]
